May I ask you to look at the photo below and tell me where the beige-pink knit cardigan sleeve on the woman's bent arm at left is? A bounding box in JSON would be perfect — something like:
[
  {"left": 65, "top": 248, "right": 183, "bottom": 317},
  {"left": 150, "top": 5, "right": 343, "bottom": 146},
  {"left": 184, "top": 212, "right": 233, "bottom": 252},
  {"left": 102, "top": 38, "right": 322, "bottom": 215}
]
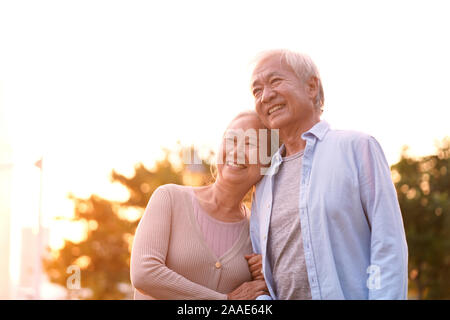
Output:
[{"left": 130, "top": 187, "right": 227, "bottom": 300}]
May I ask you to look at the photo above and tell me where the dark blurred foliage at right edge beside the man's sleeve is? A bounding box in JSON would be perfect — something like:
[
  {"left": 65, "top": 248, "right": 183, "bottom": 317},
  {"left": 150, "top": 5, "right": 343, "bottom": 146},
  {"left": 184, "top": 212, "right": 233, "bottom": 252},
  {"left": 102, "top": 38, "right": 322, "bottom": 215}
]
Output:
[{"left": 391, "top": 138, "right": 450, "bottom": 299}]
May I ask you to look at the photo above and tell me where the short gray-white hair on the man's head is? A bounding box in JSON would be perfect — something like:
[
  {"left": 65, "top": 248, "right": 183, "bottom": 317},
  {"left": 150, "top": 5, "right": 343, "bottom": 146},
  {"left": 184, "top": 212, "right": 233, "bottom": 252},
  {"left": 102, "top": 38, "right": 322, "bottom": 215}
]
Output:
[{"left": 254, "top": 49, "right": 325, "bottom": 111}]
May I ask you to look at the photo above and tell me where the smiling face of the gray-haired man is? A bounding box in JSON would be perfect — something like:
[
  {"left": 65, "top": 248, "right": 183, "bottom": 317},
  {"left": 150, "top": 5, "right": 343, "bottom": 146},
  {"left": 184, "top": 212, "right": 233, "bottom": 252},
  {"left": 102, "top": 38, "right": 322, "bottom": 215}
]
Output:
[{"left": 251, "top": 55, "right": 314, "bottom": 129}]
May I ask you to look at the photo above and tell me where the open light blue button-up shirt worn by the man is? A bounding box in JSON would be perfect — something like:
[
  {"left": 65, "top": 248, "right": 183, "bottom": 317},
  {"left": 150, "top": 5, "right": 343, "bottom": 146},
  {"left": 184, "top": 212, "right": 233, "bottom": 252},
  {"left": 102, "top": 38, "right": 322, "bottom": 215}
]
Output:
[{"left": 250, "top": 120, "right": 408, "bottom": 299}]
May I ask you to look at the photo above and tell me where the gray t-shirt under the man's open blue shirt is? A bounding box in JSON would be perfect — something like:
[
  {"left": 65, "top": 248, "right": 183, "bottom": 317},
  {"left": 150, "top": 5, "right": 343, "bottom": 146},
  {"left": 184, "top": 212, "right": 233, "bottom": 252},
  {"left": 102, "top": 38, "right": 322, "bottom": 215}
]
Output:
[{"left": 268, "top": 150, "right": 311, "bottom": 300}]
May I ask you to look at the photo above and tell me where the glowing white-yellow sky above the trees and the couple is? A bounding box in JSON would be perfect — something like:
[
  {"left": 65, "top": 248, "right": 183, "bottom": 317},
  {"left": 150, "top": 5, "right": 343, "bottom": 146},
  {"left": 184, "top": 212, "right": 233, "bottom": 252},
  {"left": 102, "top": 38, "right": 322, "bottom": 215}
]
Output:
[{"left": 0, "top": 0, "right": 450, "bottom": 294}]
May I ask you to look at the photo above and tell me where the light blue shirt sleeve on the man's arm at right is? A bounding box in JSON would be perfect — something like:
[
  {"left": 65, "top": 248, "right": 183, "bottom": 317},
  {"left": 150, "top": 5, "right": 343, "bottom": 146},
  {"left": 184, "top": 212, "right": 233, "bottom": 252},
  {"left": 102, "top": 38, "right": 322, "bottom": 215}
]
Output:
[{"left": 357, "top": 137, "right": 408, "bottom": 300}]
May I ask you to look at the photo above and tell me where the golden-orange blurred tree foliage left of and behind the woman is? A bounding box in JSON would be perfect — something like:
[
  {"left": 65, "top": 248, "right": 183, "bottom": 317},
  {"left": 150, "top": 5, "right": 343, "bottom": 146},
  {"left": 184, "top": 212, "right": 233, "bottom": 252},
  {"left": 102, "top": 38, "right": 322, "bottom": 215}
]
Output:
[{"left": 44, "top": 147, "right": 212, "bottom": 299}]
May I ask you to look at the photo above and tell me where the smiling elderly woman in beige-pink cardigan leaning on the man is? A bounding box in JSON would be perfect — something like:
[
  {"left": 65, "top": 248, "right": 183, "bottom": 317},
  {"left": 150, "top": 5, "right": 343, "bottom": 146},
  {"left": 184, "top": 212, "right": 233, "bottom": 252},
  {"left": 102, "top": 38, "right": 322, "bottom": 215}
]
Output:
[{"left": 131, "top": 111, "right": 267, "bottom": 300}]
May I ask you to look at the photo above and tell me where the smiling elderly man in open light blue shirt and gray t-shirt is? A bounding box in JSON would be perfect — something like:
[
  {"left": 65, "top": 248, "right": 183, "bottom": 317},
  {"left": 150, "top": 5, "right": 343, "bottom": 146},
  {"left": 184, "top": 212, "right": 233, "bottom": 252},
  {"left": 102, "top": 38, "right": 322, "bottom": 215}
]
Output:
[{"left": 250, "top": 50, "right": 408, "bottom": 299}]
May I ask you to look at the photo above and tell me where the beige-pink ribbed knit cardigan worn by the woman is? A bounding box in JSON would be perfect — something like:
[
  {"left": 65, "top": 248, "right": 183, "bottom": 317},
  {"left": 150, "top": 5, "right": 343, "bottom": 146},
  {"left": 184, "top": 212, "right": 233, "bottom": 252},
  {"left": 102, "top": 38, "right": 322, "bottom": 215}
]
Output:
[{"left": 130, "top": 184, "right": 252, "bottom": 299}]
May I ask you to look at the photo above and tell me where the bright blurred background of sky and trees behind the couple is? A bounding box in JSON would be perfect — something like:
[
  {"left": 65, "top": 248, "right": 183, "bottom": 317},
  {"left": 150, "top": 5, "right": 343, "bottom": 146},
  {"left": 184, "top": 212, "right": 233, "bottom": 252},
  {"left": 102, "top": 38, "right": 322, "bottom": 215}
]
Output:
[{"left": 0, "top": 0, "right": 450, "bottom": 299}]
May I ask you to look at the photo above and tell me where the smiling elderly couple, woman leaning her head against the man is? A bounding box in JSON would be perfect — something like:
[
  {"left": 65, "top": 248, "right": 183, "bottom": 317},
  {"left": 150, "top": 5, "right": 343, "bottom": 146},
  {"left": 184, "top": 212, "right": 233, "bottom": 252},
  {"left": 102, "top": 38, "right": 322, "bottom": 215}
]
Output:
[{"left": 131, "top": 50, "right": 408, "bottom": 300}]
